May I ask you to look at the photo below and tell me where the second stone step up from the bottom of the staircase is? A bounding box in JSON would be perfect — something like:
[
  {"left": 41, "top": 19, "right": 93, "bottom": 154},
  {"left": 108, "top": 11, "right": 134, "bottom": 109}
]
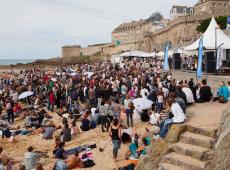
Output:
[{"left": 171, "top": 142, "right": 209, "bottom": 160}]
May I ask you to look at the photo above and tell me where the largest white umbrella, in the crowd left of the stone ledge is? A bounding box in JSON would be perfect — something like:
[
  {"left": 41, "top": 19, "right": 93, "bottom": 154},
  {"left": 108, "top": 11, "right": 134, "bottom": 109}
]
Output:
[{"left": 133, "top": 98, "right": 153, "bottom": 111}]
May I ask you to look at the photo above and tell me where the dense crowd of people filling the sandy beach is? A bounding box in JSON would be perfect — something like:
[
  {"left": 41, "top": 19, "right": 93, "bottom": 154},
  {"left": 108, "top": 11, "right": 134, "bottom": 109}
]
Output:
[{"left": 0, "top": 59, "right": 230, "bottom": 170}]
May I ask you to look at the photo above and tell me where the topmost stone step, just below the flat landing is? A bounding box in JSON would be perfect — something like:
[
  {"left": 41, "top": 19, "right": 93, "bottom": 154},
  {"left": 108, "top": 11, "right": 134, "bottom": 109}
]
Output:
[{"left": 187, "top": 125, "right": 218, "bottom": 138}]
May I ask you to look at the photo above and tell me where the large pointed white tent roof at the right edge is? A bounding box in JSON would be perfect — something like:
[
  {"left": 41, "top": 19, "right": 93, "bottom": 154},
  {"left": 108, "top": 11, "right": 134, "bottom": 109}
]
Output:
[{"left": 185, "top": 17, "right": 230, "bottom": 51}]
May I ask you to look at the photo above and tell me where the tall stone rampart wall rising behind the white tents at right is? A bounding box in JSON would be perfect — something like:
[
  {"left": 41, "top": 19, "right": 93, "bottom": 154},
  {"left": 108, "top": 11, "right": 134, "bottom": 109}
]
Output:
[{"left": 143, "top": 9, "right": 230, "bottom": 52}]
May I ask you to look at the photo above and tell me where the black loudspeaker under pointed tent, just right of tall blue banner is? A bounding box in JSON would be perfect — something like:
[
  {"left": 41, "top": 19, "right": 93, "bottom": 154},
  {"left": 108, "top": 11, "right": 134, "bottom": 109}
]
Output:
[{"left": 204, "top": 51, "right": 216, "bottom": 73}]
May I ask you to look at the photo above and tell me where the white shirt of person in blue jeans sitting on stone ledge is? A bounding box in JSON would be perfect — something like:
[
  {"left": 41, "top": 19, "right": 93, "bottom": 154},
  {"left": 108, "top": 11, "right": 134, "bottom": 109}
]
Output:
[{"left": 171, "top": 103, "right": 186, "bottom": 123}]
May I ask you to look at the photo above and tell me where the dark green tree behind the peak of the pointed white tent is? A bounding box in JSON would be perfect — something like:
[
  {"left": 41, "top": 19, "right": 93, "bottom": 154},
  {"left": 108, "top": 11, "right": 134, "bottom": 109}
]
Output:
[{"left": 196, "top": 16, "right": 227, "bottom": 33}]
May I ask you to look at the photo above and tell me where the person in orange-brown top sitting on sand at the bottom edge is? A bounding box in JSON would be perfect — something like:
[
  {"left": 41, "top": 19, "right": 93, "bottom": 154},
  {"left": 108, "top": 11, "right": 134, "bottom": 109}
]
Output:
[{"left": 65, "top": 151, "right": 83, "bottom": 169}]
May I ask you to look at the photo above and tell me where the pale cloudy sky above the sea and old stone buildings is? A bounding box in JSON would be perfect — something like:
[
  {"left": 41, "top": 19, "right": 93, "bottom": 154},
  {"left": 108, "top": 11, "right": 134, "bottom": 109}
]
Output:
[{"left": 0, "top": 0, "right": 197, "bottom": 59}]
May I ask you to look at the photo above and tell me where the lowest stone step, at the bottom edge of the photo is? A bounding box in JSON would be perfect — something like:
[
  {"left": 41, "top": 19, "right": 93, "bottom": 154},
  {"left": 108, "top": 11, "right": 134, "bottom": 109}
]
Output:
[{"left": 161, "top": 152, "right": 205, "bottom": 170}]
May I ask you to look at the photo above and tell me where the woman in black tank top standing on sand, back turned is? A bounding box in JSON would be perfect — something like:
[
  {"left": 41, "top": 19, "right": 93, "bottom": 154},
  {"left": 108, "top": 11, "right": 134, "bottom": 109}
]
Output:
[{"left": 109, "top": 118, "right": 121, "bottom": 161}]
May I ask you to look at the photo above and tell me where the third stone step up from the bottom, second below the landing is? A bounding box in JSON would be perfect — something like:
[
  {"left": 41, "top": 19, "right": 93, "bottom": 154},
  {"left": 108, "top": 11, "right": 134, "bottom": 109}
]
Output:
[{"left": 180, "top": 132, "right": 214, "bottom": 149}]
